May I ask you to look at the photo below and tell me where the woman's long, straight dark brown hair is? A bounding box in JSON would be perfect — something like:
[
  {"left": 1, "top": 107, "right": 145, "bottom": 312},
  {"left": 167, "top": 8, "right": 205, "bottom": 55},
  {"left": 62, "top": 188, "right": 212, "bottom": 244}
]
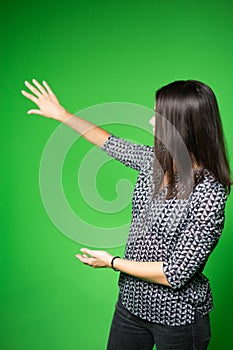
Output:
[{"left": 154, "top": 80, "right": 232, "bottom": 198}]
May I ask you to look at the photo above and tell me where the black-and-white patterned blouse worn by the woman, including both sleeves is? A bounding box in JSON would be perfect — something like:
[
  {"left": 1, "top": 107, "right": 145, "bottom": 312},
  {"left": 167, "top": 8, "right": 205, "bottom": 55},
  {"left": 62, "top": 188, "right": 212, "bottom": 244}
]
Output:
[{"left": 101, "top": 134, "right": 227, "bottom": 326}]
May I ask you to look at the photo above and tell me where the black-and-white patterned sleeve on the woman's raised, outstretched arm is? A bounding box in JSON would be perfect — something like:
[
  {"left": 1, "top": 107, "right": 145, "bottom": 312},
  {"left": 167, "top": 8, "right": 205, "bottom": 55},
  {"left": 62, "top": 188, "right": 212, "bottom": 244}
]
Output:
[{"left": 101, "top": 134, "right": 154, "bottom": 171}]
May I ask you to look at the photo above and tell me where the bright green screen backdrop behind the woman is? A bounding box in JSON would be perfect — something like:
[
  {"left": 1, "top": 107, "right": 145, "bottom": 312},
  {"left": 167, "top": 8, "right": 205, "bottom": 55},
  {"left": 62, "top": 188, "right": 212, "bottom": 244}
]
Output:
[{"left": 0, "top": 0, "right": 233, "bottom": 350}]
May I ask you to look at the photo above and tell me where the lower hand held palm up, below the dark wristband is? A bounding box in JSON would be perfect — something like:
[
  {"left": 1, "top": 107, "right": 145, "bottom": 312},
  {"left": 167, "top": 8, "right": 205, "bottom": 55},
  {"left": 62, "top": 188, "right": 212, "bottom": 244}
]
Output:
[{"left": 75, "top": 248, "right": 113, "bottom": 268}]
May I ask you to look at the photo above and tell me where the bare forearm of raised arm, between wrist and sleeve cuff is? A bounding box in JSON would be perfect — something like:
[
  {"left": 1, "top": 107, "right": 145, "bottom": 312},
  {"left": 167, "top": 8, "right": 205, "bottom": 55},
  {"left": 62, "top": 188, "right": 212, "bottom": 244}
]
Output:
[{"left": 62, "top": 111, "right": 111, "bottom": 147}]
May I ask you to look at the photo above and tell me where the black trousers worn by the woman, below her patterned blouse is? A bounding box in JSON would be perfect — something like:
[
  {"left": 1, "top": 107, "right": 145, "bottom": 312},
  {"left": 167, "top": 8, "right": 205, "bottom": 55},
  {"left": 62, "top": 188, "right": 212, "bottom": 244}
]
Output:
[{"left": 107, "top": 298, "right": 211, "bottom": 350}]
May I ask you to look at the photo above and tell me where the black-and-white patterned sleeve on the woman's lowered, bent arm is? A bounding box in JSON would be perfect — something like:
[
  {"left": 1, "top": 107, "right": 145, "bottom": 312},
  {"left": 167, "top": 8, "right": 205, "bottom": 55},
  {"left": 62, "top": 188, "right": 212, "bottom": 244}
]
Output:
[{"left": 163, "top": 182, "right": 226, "bottom": 289}]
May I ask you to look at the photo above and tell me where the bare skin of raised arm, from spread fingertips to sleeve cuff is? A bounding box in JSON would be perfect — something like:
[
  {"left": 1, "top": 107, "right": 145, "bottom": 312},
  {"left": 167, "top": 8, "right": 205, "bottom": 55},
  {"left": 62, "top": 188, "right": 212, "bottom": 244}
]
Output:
[{"left": 21, "top": 79, "right": 111, "bottom": 147}]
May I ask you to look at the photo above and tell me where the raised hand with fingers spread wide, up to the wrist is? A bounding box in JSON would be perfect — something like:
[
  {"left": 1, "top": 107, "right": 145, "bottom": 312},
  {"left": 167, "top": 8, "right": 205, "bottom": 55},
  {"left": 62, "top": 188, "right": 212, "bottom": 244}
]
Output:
[{"left": 21, "top": 79, "right": 68, "bottom": 122}]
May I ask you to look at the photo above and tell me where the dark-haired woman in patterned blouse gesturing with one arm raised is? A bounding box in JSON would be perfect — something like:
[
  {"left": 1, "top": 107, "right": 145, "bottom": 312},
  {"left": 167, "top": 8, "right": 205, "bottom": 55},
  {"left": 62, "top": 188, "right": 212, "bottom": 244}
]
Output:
[{"left": 22, "top": 80, "right": 232, "bottom": 350}]
